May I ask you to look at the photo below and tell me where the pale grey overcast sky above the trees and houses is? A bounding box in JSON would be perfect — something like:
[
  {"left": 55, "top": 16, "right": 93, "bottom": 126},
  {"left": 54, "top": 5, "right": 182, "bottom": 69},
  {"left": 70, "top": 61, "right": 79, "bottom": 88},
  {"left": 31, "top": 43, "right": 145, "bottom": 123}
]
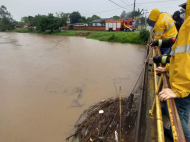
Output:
[{"left": 0, "top": 0, "right": 187, "bottom": 21}]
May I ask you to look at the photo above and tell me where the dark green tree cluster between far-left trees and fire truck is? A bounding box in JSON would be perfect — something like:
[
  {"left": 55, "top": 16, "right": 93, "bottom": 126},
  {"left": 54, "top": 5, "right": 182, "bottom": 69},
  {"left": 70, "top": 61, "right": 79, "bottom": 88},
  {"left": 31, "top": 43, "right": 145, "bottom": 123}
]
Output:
[{"left": 18, "top": 11, "right": 104, "bottom": 32}]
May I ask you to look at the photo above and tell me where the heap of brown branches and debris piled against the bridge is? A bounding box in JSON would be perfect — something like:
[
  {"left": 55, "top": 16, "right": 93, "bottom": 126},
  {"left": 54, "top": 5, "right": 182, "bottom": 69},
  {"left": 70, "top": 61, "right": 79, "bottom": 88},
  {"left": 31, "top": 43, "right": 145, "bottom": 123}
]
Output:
[{"left": 66, "top": 97, "right": 138, "bottom": 142}]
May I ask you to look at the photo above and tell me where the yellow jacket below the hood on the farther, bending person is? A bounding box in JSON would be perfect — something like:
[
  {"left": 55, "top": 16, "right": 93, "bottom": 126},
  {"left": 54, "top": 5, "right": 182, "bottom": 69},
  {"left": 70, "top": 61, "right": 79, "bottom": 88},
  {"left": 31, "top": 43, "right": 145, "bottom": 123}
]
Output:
[{"left": 154, "top": 13, "right": 177, "bottom": 40}]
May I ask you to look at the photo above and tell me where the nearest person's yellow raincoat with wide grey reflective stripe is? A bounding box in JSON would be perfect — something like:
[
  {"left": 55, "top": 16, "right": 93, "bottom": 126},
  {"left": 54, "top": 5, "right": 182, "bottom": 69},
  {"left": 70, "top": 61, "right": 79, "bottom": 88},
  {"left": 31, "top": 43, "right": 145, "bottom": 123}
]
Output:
[{"left": 165, "top": 0, "right": 190, "bottom": 98}]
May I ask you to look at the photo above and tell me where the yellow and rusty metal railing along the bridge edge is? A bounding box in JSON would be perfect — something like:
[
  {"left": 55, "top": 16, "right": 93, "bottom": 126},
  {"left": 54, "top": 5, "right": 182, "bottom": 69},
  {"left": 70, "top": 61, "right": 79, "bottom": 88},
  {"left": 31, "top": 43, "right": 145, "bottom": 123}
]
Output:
[{"left": 149, "top": 47, "right": 186, "bottom": 142}]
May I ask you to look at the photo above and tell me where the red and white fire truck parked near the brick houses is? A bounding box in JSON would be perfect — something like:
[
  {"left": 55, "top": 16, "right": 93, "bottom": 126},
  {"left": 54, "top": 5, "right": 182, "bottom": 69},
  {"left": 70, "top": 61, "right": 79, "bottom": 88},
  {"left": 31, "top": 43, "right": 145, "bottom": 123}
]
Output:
[{"left": 105, "top": 19, "right": 135, "bottom": 32}]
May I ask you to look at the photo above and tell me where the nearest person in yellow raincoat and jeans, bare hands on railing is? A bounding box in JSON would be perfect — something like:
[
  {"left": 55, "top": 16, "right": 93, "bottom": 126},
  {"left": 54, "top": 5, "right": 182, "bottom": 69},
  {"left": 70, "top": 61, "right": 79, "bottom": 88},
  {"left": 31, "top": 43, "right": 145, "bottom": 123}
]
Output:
[{"left": 155, "top": 0, "right": 190, "bottom": 142}]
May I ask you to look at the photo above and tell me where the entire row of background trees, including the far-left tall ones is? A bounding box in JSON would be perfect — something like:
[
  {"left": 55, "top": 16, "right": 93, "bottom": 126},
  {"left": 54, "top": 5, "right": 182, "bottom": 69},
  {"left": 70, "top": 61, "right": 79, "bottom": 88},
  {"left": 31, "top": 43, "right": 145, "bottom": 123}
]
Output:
[{"left": 0, "top": 5, "right": 148, "bottom": 32}]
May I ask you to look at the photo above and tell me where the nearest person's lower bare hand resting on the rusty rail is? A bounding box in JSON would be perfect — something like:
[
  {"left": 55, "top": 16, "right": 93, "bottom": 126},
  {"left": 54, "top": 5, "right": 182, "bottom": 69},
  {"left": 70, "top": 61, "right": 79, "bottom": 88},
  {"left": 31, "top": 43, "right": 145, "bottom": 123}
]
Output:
[{"left": 159, "top": 88, "right": 177, "bottom": 102}]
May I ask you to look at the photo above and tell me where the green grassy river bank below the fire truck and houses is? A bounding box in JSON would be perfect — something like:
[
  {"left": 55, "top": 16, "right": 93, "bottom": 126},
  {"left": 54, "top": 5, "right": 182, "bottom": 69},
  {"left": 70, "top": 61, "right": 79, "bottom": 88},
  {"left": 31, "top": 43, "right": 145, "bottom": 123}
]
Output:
[{"left": 8, "top": 29, "right": 149, "bottom": 45}]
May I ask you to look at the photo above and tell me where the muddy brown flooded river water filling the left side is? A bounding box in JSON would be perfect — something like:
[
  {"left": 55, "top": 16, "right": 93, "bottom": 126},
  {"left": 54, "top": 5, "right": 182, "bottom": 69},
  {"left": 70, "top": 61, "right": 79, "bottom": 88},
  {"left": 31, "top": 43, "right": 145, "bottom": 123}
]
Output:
[{"left": 0, "top": 33, "right": 146, "bottom": 142}]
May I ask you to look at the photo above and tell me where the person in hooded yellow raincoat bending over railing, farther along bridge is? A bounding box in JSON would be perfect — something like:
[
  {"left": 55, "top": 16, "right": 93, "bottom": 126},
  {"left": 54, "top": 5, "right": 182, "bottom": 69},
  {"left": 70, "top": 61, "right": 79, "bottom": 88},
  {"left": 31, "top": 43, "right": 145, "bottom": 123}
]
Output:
[{"left": 147, "top": 8, "right": 177, "bottom": 54}]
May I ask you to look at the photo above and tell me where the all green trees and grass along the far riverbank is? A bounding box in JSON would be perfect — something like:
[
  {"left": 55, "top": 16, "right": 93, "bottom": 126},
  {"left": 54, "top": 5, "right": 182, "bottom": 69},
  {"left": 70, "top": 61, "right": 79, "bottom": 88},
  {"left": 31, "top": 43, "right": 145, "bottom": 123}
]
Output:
[{"left": 0, "top": 5, "right": 149, "bottom": 44}]
